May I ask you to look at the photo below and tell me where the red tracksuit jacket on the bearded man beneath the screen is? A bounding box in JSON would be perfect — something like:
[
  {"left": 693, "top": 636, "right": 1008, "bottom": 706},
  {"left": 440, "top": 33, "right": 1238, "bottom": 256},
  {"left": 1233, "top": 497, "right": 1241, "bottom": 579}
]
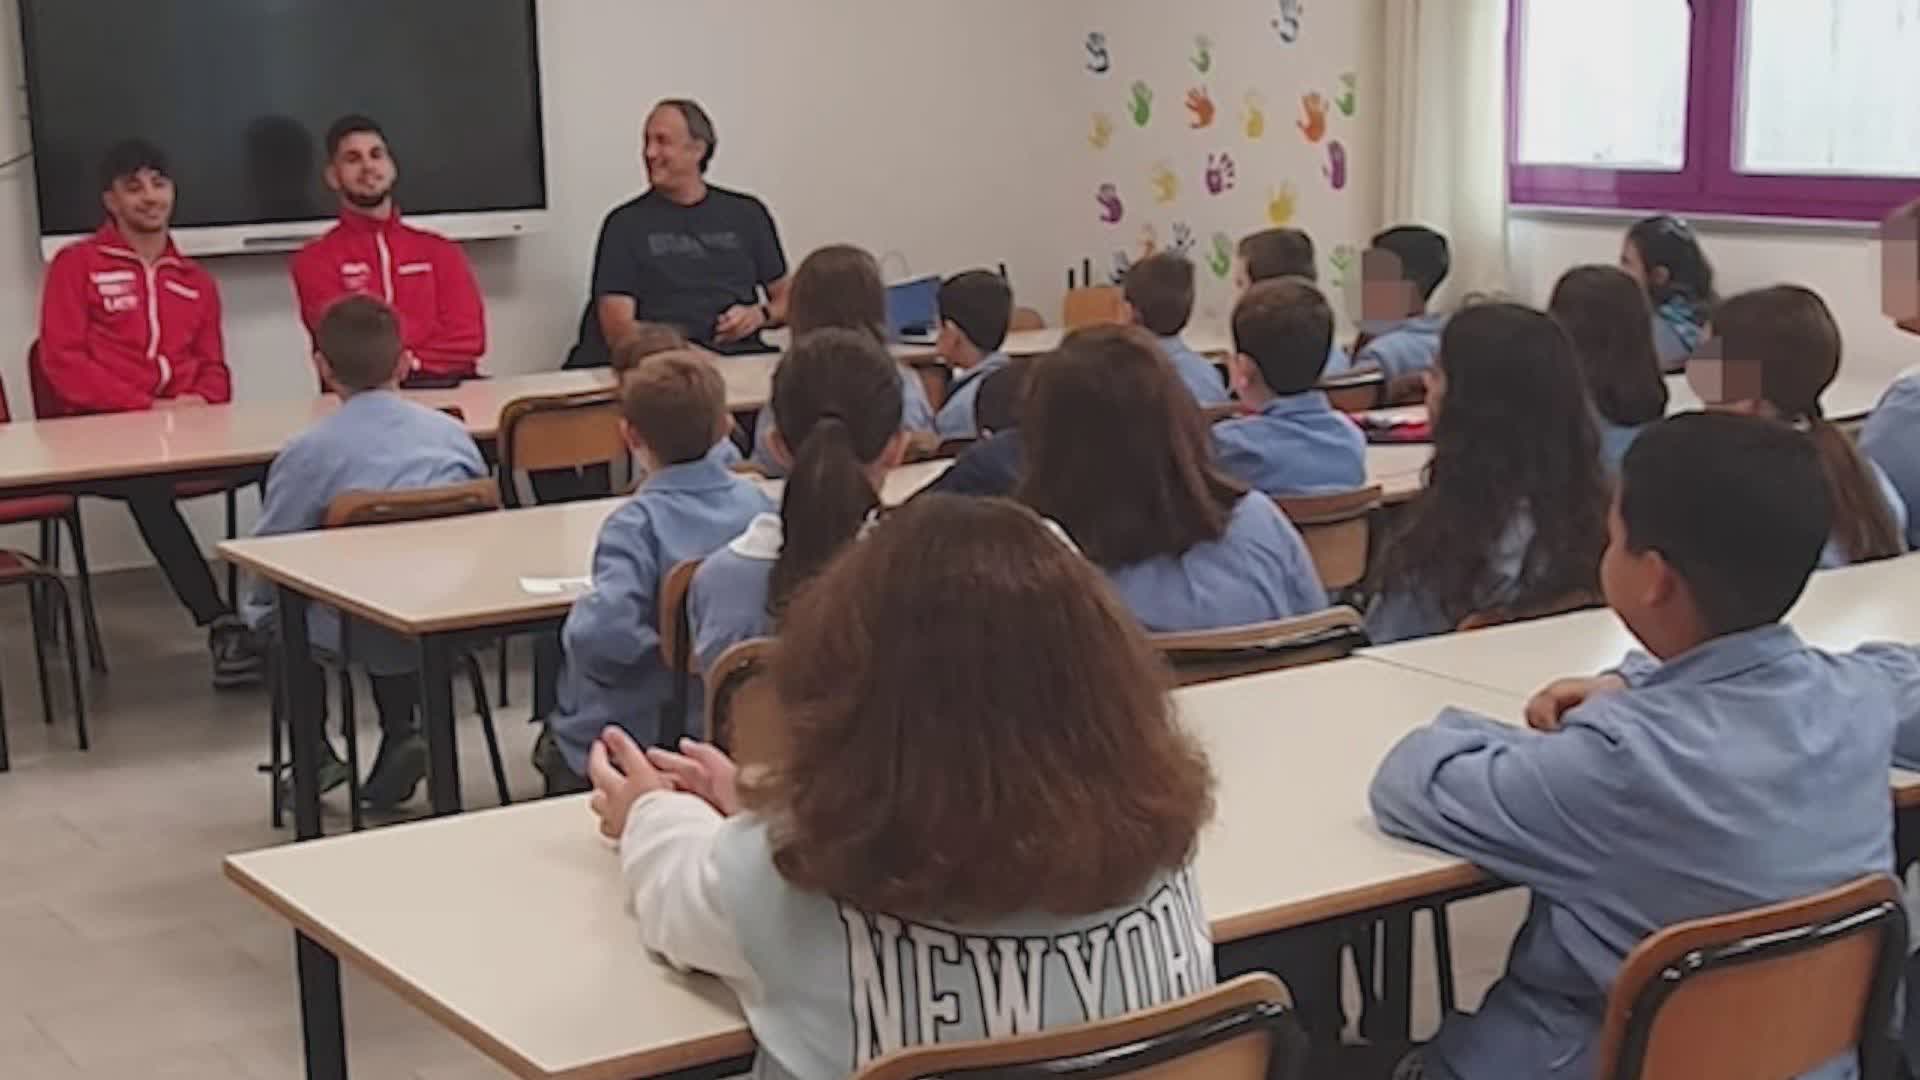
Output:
[{"left": 294, "top": 209, "right": 486, "bottom": 377}]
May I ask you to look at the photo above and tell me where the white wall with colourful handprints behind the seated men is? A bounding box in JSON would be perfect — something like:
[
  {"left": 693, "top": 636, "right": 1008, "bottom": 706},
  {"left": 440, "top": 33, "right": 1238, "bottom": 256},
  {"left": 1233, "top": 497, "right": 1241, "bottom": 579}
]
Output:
[{"left": 0, "top": 0, "right": 1379, "bottom": 567}]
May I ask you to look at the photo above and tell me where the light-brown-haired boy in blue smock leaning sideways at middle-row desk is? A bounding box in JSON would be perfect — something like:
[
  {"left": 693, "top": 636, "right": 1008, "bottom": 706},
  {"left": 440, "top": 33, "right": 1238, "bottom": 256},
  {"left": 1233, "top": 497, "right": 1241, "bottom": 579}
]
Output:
[{"left": 534, "top": 352, "right": 774, "bottom": 796}]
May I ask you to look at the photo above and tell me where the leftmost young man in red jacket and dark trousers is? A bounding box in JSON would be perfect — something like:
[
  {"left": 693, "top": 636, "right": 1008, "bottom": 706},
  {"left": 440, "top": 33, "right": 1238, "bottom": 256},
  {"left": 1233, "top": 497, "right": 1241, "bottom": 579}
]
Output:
[{"left": 31, "top": 140, "right": 261, "bottom": 686}]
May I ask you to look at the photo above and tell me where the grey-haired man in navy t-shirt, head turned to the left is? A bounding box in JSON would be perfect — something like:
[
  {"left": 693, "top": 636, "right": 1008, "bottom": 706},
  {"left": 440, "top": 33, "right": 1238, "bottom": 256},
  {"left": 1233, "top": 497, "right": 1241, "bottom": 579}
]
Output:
[{"left": 566, "top": 100, "right": 789, "bottom": 367}]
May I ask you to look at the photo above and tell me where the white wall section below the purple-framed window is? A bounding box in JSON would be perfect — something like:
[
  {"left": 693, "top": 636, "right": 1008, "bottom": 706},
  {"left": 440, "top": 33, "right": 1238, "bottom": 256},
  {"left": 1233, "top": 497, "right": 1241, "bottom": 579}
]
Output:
[{"left": 1509, "top": 215, "right": 1920, "bottom": 382}]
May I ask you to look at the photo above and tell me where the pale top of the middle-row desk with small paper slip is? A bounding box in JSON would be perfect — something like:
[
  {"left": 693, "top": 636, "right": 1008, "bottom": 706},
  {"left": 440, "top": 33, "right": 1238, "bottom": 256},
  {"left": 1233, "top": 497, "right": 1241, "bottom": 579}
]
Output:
[{"left": 219, "top": 461, "right": 952, "bottom": 634}]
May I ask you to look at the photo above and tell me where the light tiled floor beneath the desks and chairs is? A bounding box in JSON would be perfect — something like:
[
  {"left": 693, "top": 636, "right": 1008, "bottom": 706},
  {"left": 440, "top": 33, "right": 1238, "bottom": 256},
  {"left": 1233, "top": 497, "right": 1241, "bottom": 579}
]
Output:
[{"left": 0, "top": 575, "right": 1521, "bottom": 1080}]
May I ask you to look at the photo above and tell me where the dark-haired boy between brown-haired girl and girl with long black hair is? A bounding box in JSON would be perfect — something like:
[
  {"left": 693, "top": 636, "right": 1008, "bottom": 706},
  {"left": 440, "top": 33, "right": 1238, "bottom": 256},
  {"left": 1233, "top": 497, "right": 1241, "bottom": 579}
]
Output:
[{"left": 1213, "top": 277, "right": 1367, "bottom": 496}]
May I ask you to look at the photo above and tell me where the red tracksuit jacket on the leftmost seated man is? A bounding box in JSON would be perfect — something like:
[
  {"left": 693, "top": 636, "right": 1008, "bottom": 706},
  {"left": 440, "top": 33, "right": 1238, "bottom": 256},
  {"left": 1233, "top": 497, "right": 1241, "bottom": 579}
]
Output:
[{"left": 31, "top": 221, "right": 232, "bottom": 417}]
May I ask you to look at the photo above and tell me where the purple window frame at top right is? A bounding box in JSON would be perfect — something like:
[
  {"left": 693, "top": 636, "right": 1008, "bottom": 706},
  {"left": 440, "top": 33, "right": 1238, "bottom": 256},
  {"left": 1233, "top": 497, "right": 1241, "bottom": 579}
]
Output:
[{"left": 1507, "top": 0, "right": 1920, "bottom": 223}]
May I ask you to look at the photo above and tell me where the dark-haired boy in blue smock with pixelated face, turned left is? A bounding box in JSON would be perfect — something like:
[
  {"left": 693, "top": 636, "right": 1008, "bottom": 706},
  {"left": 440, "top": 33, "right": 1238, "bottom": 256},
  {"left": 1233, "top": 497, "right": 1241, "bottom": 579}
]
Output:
[{"left": 1354, "top": 225, "right": 1453, "bottom": 402}]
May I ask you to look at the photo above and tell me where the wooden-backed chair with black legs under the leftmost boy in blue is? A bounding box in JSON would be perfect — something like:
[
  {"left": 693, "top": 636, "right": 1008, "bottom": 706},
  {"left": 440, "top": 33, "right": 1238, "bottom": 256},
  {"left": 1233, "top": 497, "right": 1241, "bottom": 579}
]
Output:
[{"left": 267, "top": 479, "right": 513, "bottom": 832}]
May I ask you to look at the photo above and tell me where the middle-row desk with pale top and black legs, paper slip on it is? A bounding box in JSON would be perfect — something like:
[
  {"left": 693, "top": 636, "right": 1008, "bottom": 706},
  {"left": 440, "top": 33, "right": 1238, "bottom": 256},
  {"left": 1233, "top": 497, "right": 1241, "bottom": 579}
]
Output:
[{"left": 219, "top": 453, "right": 950, "bottom": 840}]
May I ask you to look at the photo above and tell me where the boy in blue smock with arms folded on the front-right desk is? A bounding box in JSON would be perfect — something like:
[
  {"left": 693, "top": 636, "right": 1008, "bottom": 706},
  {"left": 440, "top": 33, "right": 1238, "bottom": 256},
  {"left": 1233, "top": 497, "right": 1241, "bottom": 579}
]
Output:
[{"left": 1371, "top": 413, "right": 1920, "bottom": 1080}]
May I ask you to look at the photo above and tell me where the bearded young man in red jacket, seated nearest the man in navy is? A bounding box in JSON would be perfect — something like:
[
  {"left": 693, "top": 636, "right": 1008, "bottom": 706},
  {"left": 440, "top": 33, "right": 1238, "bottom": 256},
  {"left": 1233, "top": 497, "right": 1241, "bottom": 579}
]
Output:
[{"left": 294, "top": 115, "right": 486, "bottom": 388}]
